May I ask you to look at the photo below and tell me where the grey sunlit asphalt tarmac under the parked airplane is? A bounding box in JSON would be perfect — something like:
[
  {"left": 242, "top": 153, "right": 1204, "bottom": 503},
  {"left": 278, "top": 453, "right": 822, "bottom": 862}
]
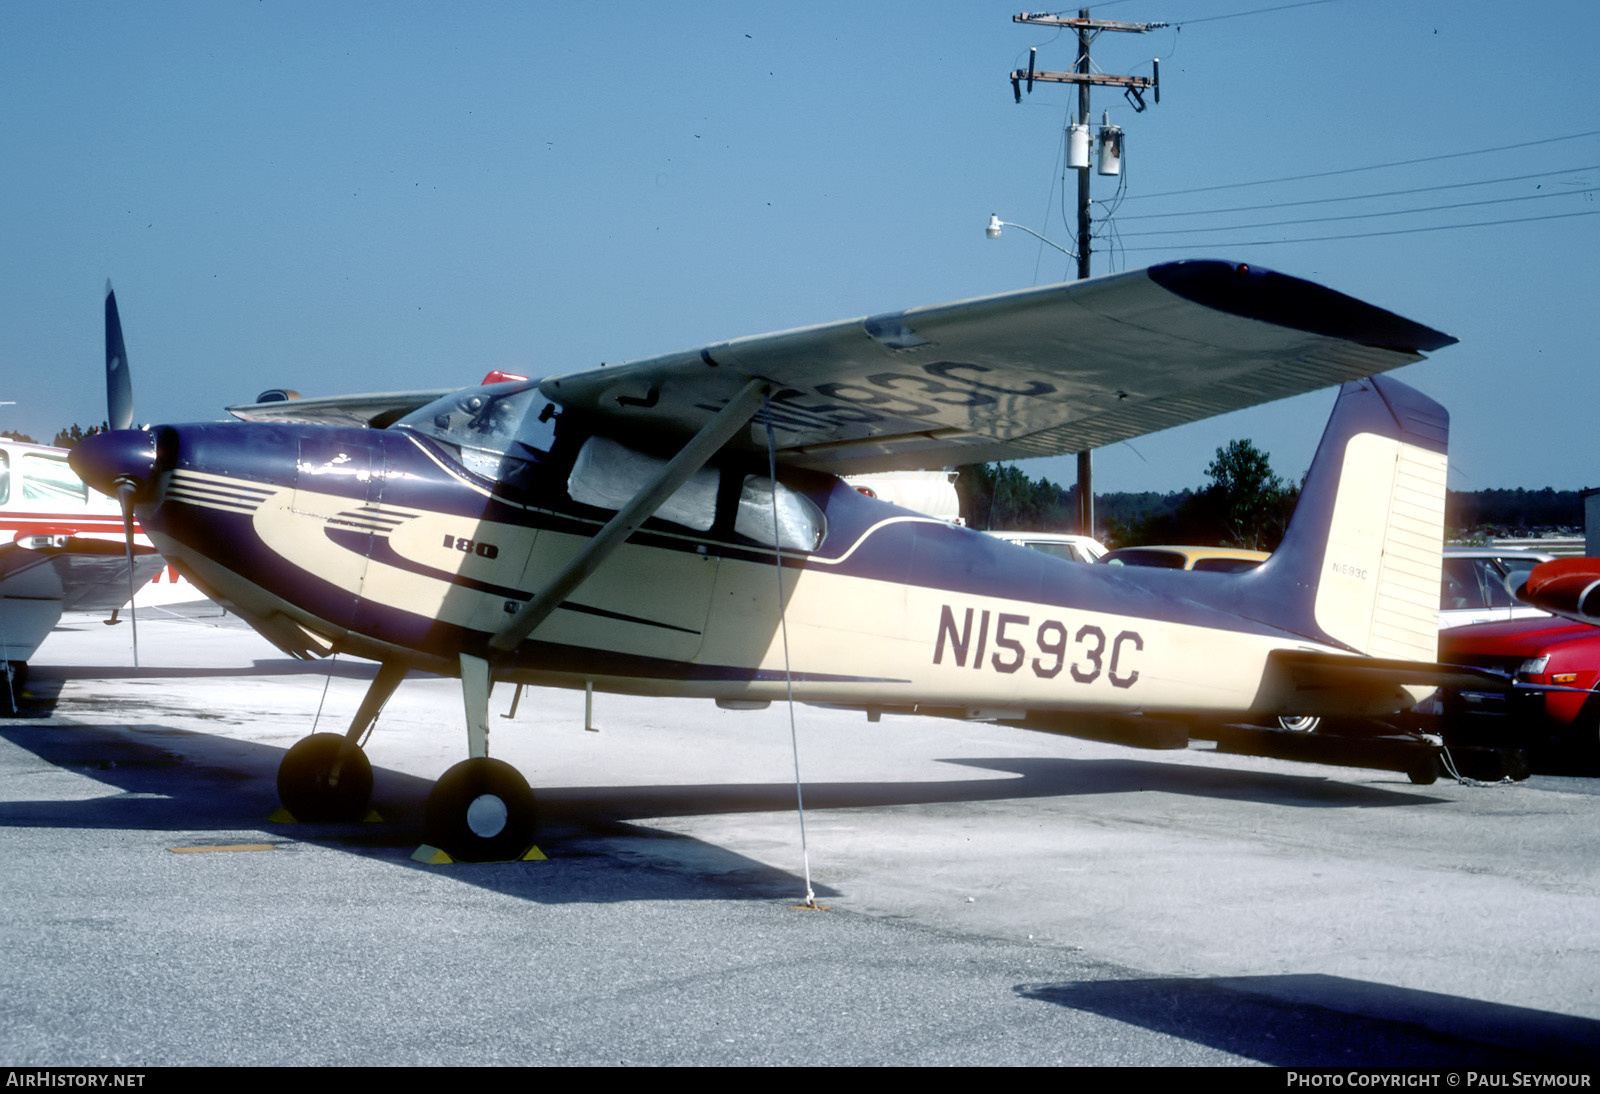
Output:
[{"left": 0, "top": 614, "right": 1600, "bottom": 1073}]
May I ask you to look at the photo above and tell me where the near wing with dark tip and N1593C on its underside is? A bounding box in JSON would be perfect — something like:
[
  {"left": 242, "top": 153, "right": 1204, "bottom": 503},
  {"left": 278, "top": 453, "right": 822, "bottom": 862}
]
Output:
[{"left": 541, "top": 261, "right": 1456, "bottom": 475}]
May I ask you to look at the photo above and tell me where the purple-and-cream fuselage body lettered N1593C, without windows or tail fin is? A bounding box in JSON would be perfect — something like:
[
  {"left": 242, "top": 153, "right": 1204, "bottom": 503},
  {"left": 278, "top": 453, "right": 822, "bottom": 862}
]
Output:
[{"left": 124, "top": 424, "right": 1326, "bottom": 718}]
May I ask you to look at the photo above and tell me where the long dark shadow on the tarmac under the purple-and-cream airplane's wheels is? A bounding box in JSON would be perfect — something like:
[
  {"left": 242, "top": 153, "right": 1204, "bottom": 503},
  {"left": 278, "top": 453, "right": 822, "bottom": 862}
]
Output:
[{"left": 0, "top": 720, "right": 1440, "bottom": 902}]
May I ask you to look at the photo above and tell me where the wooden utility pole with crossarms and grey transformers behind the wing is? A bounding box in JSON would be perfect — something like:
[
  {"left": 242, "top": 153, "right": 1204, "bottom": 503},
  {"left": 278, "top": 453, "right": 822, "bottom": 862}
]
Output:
[{"left": 1011, "top": 8, "right": 1166, "bottom": 536}]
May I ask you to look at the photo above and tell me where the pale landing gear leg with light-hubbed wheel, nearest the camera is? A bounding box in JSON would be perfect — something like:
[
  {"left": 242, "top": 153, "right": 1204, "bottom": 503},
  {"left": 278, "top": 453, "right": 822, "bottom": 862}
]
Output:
[{"left": 427, "top": 654, "right": 534, "bottom": 862}]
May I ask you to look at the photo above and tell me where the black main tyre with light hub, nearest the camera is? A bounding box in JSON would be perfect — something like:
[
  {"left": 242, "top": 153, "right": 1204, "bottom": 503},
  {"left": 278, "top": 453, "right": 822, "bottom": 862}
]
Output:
[{"left": 427, "top": 757, "right": 534, "bottom": 862}]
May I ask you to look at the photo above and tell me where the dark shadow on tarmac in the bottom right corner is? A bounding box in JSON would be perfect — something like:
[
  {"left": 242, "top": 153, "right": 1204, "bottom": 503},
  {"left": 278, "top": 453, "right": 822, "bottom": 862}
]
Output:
[{"left": 1014, "top": 974, "right": 1600, "bottom": 1072}]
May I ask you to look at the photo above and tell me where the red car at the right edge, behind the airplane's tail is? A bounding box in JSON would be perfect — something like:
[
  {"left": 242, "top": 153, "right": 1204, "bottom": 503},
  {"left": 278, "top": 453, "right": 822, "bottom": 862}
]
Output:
[{"left": 1438, "top": 616, "right": 1600, "bottom": 766}]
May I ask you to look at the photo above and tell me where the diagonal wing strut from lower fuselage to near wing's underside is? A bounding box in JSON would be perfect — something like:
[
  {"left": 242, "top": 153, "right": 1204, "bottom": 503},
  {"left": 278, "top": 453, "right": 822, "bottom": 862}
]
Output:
[{"left": 490, "top": 371, "right": 771, "bottom": 653}]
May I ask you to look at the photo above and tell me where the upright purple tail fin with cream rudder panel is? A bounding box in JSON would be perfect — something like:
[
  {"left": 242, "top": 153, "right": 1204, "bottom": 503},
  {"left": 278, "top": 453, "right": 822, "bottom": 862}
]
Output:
[{"left": 1251, "top": 376, "right": 1450, "bottom": 661}]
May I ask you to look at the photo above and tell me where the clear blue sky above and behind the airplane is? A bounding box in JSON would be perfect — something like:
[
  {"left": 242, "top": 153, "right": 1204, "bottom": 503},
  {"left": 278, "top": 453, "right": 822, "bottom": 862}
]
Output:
[{"left": 0, "top": 0, "right": 1600, "bottom": 491}]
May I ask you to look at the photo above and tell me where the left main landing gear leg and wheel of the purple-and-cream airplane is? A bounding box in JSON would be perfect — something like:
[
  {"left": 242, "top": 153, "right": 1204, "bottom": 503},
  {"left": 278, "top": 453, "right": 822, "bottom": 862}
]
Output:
[{"left": 278, "top": 661, "right": 406, "bottom": 822}]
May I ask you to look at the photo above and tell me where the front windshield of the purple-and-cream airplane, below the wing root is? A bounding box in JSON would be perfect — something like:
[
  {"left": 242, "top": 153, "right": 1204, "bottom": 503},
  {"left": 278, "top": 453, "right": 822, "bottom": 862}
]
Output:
[{"left": 390, "top": 381, "right": 560, "bottom": 478}]
